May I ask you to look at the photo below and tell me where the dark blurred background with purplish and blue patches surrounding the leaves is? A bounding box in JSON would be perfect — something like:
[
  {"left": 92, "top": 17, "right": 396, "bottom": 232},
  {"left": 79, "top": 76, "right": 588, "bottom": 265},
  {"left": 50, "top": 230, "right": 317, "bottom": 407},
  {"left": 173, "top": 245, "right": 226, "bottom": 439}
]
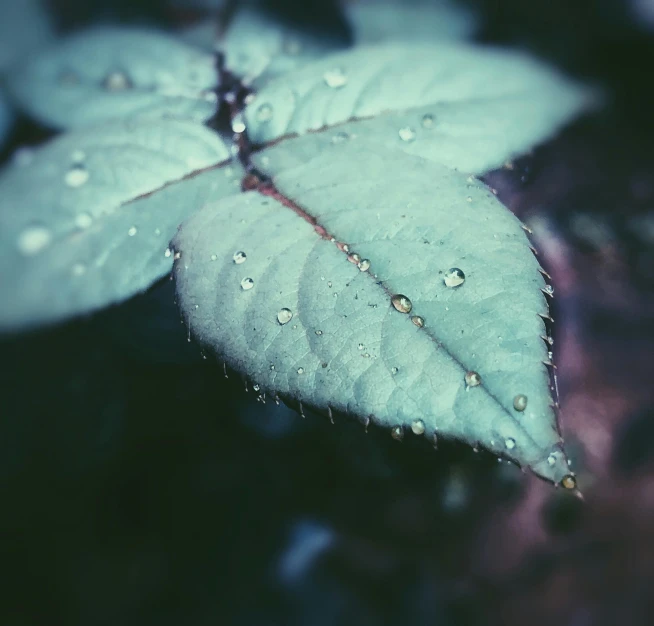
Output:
[{"left": 0, "top": 0, "right": 654, "bottom": 626}]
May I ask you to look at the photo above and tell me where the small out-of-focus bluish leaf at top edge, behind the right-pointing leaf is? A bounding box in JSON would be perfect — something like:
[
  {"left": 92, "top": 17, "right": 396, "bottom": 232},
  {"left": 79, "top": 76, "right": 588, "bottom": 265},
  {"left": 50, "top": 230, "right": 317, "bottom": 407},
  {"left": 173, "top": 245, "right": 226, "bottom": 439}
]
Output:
[{"left": 345, "top": 0, "right": 477, "bottom": 44}]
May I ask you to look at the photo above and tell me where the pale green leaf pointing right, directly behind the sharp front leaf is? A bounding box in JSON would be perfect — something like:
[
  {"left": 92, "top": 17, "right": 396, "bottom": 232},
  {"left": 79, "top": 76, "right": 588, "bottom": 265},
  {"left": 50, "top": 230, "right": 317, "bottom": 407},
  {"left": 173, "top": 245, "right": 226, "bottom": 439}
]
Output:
[{"left": 245, "top": 43, "right": 592, "bottom": 172}]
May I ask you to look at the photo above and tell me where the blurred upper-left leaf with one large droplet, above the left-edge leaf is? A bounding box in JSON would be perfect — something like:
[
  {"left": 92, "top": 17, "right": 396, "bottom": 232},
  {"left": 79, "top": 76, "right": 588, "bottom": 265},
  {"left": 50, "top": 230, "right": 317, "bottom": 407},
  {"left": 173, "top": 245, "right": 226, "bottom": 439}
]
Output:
[{"left": 9, "top": 28, "right": 218, "bottom": 128}]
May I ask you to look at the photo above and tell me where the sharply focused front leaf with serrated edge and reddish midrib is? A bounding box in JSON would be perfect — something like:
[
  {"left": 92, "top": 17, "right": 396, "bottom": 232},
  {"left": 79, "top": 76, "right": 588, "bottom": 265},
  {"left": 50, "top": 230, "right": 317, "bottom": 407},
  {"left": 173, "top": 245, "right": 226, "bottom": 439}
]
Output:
[{"left": 173, "top": 136, "right": 569, "bottom": 482}]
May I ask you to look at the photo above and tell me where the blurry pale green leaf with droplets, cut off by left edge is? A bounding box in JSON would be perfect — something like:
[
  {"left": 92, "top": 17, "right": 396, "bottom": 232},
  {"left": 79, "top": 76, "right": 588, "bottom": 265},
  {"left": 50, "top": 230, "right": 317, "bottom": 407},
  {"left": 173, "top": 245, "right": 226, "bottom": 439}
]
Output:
[{"left": 0, "top": 120, "right": 240, "bottom": 331}]
